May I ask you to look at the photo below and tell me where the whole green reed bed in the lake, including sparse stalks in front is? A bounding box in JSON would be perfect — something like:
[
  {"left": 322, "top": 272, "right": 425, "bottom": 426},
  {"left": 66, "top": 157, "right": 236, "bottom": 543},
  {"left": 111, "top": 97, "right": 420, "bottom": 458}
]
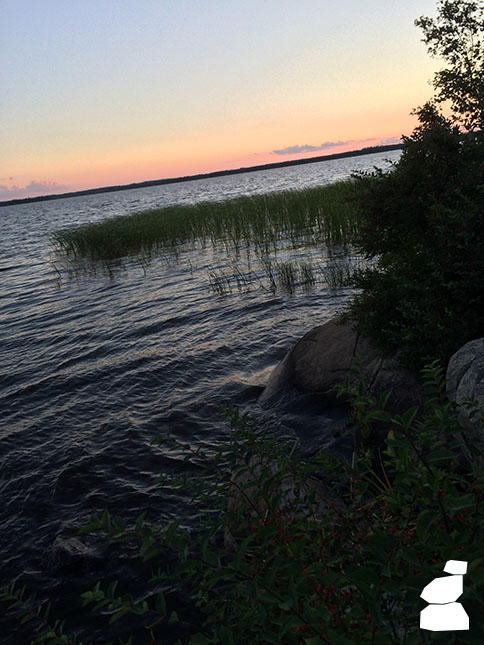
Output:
[{"left": 51, "top": 180, "right": 362, "bottom": 295}]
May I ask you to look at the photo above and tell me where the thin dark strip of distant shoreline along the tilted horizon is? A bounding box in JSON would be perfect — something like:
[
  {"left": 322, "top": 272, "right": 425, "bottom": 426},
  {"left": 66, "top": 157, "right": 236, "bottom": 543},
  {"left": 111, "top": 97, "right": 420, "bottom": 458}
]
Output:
[{"left": 0, "top": 143, "right": 403, "bottom": 208}]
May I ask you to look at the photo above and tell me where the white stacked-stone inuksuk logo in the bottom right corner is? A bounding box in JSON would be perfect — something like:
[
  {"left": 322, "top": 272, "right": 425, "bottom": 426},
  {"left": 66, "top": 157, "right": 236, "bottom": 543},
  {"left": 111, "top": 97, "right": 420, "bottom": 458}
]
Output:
[{"left": 420, "top": 560, "right": 469, "bottom": 632}]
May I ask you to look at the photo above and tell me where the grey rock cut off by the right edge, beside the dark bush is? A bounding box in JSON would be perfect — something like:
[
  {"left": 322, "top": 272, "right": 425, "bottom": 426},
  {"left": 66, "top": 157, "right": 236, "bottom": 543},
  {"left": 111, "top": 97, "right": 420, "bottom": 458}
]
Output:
[{"left": 446, "top": 338, "right": 484, "bottom": 440}]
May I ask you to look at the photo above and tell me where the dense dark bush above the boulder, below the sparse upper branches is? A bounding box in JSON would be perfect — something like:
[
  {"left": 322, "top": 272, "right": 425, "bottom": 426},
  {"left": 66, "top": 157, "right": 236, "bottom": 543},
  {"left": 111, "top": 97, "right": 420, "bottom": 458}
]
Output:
[{"left": 347, "top": 103, "right": 484, "bottom": 368}]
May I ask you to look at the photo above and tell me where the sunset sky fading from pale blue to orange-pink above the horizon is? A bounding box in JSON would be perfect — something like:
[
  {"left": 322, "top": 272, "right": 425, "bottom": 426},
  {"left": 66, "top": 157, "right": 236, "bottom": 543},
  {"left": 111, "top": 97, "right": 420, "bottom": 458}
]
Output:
[{"left": 0, "top": 0, "right": 439, "bottom": 200}]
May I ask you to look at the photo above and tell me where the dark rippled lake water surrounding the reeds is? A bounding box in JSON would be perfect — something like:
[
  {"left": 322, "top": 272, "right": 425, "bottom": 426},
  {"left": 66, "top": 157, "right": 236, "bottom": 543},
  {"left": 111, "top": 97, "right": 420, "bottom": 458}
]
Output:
[{"left": 0, "top": 151, "right": 400, "bottom": 644}]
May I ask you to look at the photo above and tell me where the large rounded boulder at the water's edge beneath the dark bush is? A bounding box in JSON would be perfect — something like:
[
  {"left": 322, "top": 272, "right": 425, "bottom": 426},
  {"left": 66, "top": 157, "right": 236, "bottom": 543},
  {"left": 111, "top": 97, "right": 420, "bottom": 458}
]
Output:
[{"left": 259, "top": 318, "right": 424, "bottom": 414}]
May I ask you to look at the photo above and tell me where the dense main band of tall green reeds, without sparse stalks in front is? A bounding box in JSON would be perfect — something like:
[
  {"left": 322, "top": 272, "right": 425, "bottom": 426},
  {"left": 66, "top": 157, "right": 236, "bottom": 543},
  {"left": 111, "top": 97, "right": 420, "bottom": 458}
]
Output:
[{"left": 52, "top": 181, "right": 357, "bottom": 262}]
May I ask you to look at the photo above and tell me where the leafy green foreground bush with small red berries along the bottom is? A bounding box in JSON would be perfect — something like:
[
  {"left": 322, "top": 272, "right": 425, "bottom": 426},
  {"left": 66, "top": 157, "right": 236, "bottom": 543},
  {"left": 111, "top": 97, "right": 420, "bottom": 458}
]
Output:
[{"left": 3, "top": 364, "right": 484, "bottom": 645}]
